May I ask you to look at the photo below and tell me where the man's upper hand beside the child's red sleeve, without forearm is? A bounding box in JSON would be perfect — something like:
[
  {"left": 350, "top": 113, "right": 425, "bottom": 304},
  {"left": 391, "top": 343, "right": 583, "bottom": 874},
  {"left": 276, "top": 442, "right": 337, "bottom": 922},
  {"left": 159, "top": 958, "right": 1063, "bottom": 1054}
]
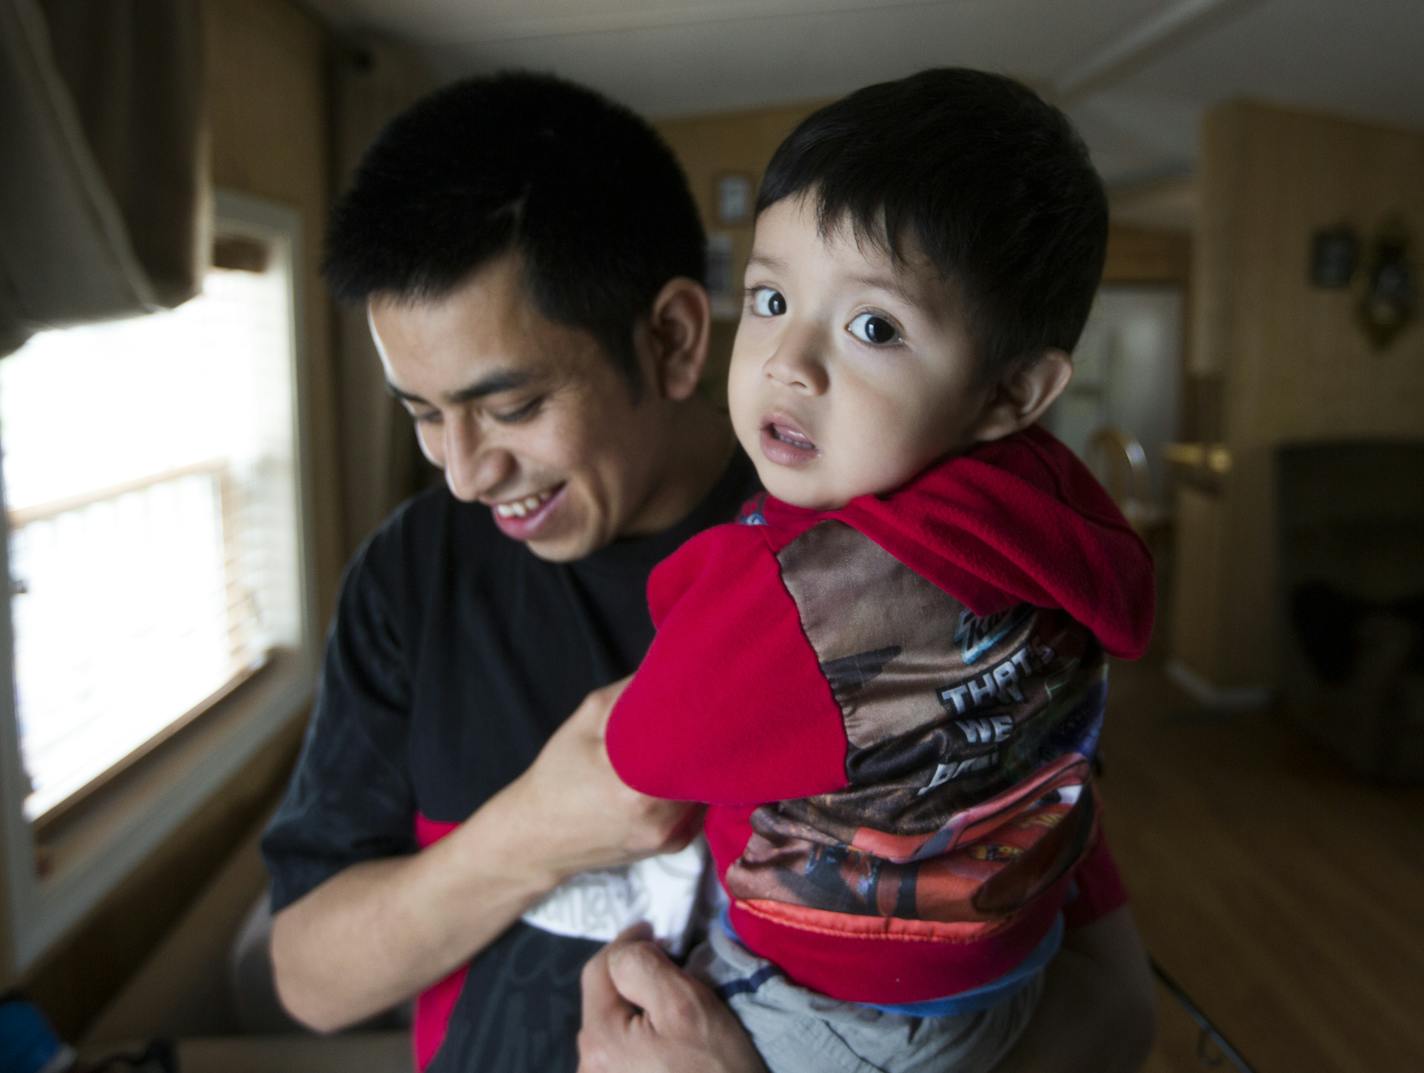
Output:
[{"left": 501, "top": 679, "right": 701, "bottom": 887}]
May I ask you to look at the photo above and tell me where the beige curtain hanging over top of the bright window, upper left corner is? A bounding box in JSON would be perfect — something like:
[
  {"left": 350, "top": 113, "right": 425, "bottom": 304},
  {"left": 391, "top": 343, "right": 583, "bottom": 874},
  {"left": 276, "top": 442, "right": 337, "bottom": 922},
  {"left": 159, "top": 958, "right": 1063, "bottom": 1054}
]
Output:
[{"left": 0, "top": 0, "right": 211, "bottom": 354}]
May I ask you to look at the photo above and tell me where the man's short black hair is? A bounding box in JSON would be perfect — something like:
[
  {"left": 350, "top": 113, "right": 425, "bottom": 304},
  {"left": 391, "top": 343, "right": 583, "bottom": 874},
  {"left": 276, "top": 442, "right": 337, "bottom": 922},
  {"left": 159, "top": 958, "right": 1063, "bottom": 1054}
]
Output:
[{"left": 322, "top": 73, "right": 706, "bottom": 390}]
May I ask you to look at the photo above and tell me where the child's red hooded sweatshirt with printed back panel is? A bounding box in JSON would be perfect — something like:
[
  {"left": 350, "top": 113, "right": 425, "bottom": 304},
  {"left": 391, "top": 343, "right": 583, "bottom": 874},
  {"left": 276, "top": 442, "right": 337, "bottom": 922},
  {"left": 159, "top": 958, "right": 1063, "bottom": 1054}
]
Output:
[{"left": 608, "top": 428, "right": 1153, "bottom": 1005}]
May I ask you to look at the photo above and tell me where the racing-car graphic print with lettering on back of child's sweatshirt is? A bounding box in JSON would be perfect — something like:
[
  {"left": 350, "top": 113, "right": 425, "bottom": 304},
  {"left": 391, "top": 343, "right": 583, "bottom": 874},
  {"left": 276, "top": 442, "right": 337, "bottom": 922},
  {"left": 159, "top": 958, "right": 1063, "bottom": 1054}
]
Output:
[{"left": 726, "top": 521, "right": 1106, "bottom": 926}]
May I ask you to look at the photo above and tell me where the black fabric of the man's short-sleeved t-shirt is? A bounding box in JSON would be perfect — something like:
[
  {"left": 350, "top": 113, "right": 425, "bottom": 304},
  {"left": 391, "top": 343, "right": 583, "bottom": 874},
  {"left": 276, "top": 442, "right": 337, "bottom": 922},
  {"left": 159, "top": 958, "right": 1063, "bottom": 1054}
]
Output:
[{"left": 262, "top": 453, "right": 755, "bottom": 1073}]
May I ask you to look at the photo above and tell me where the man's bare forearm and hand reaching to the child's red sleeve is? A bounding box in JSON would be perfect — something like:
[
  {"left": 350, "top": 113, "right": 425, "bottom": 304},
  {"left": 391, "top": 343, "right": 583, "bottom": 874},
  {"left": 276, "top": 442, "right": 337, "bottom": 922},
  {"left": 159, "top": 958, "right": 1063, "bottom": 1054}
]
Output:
[{"left": 272, "top": 679, "right": 701, "bottom": 1032}]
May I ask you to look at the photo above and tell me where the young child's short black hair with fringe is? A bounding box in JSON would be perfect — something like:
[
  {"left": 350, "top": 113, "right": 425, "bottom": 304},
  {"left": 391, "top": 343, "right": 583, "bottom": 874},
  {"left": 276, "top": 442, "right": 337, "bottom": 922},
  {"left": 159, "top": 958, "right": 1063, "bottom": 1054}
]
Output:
[{"left": 756, "top": 68, "right": 1108, "bottom": 379}]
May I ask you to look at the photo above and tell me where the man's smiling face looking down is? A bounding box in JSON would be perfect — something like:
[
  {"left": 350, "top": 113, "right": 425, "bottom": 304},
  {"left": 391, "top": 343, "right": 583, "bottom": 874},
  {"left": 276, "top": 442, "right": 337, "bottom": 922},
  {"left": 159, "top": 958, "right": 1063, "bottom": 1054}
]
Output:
[{"left": 369, "top": 255, "right": 676, "bottom": 562}]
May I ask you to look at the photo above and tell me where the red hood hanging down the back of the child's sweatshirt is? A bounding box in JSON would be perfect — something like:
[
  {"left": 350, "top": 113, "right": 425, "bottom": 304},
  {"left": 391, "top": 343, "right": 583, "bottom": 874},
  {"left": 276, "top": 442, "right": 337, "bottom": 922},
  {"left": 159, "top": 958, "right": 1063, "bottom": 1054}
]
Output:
[{"left": 763, "top": 427, "right": 1156, "bottom": 659}]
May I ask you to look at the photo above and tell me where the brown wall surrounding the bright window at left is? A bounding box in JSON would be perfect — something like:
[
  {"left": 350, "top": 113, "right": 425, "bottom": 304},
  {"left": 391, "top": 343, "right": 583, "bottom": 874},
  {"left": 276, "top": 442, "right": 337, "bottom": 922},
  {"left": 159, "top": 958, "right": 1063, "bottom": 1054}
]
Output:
[{"left": 23, "top": 0, "right": 340, "bottom": 1039}]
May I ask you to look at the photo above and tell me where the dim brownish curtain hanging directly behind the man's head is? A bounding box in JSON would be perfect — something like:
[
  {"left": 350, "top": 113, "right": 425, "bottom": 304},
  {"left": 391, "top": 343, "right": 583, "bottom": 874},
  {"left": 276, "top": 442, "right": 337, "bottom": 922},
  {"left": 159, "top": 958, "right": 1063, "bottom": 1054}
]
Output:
[{"left": 332, "top": 38, "right": 436, "bottom": 554}]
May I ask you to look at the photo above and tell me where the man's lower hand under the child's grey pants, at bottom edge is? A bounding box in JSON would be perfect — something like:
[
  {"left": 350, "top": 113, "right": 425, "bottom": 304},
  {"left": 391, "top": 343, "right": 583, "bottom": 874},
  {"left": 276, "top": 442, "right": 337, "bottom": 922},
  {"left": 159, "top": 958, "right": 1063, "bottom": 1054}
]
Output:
[{"left": 578, "top": 928, "right": 766, "bottom": 1073}]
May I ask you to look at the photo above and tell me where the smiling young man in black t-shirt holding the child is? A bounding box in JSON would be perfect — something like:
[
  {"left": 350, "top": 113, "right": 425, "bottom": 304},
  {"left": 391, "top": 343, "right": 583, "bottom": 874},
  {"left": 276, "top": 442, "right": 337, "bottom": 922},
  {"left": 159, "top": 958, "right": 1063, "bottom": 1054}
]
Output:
[{"left": 263, "top": 75, "right": 1142, "bottom": 1073}]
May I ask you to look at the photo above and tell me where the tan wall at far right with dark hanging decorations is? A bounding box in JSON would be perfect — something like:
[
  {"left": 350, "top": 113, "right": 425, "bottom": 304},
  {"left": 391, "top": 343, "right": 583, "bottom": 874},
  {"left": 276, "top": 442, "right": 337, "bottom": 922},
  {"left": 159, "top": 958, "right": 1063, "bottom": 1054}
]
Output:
[{"left": 1171, "top": 102, "right": 1424, "bottom": 690}]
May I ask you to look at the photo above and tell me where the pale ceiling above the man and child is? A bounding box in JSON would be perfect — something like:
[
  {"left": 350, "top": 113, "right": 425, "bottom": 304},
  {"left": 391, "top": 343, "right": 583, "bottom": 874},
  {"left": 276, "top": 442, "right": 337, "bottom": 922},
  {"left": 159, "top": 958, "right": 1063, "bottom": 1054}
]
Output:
[{"left": 297, "top": 0, "right": 1424, "bottom": 217}]
